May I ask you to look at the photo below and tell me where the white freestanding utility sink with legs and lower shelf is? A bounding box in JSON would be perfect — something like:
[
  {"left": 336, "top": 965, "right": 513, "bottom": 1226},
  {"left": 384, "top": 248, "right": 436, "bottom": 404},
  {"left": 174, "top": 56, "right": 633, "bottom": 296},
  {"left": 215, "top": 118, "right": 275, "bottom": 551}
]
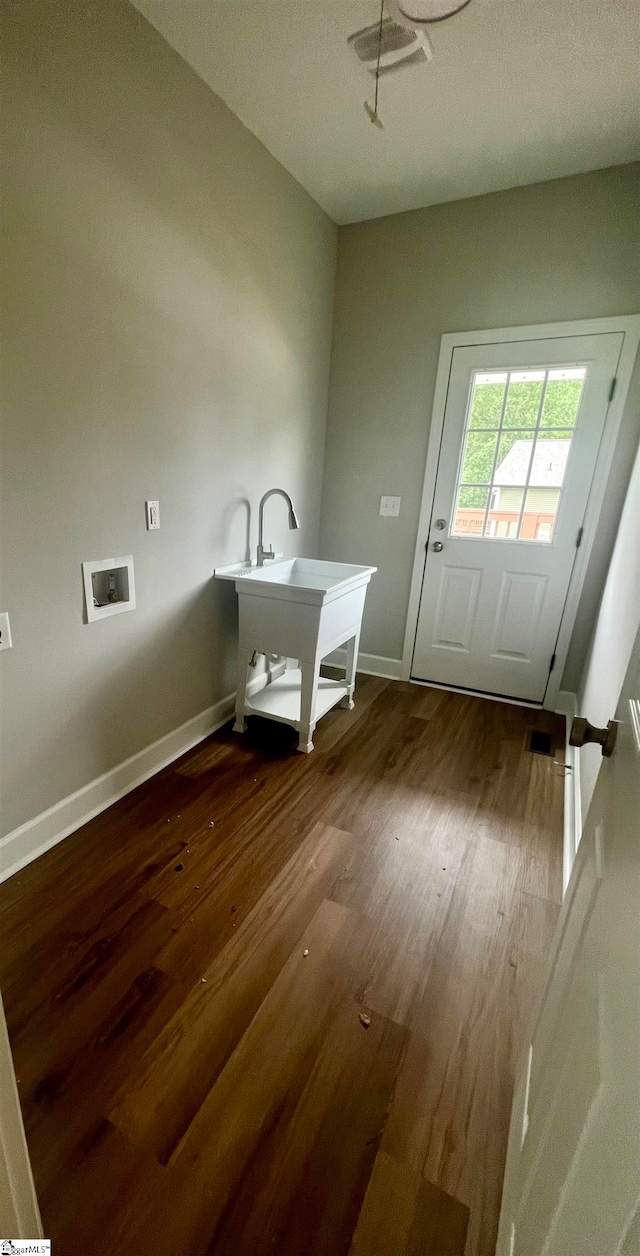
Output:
[{"left": 215, "top": 558, "right": 376, "bottom": 754}]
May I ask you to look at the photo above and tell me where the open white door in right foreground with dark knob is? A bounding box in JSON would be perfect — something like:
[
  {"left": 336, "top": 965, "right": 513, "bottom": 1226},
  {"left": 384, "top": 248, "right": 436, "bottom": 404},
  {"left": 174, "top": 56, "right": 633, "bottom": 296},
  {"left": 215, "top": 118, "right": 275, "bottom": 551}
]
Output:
[{"left": 497, "top": 622, "right": 640, "bottom": 1256}]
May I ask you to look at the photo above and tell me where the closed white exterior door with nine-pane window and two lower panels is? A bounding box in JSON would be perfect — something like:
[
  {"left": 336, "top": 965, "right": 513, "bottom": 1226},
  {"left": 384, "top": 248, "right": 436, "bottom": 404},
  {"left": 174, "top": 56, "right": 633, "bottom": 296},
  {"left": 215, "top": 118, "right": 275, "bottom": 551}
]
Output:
[{"left": 412, "top": 332, "right": 624, "bottom": 702}]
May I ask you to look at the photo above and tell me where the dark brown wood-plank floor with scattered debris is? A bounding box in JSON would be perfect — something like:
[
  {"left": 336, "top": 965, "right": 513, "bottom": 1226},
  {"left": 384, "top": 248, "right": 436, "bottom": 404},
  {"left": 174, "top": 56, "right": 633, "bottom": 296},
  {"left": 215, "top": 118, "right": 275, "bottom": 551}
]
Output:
[{"left": 0, "top": 677, "right": 563, "bottom": 1256}]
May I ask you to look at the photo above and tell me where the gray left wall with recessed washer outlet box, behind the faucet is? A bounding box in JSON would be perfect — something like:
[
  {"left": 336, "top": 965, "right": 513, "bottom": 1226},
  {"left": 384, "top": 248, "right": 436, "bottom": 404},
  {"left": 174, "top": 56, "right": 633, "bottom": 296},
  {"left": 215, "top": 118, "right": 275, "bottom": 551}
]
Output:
[{"left": 0, "top": 0, "right": 336, "bottom": 833}]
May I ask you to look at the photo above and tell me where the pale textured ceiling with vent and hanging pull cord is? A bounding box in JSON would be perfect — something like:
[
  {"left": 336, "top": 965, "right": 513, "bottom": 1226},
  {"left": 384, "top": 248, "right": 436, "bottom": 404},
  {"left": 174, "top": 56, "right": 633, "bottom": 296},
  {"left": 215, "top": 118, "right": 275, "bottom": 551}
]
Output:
[{"left": 129, "top": 0, "right": 640, "bottom": 222}]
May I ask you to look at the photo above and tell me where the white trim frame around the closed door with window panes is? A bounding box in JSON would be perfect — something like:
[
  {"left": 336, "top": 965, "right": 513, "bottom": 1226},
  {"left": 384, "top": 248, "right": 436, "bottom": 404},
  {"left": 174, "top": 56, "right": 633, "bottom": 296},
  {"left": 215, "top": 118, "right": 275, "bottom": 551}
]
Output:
[{"left": 402, "top": 314, "right": 640, "bottom": 710}]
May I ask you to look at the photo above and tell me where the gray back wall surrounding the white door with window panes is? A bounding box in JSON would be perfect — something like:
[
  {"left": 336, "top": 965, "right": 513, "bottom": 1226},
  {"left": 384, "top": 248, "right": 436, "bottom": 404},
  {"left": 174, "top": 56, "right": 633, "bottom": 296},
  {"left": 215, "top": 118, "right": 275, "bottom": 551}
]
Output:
[{"left": 320, "top": 166, "right": 640, "bottom": 690}]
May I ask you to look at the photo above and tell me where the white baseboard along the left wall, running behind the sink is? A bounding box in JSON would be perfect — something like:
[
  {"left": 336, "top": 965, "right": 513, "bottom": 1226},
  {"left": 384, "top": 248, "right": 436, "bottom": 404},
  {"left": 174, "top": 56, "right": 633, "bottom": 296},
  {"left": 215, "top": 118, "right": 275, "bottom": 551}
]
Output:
[{"left": 0, "top": 661, "right": 285, "bottom": 883}]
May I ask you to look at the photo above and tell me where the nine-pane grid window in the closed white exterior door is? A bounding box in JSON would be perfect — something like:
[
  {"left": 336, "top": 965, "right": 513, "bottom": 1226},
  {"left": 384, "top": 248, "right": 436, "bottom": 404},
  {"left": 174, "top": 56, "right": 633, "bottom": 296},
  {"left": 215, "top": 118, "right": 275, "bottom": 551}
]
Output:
[{"left": 451, "top": 367, "right": 586, "bottom": 544}]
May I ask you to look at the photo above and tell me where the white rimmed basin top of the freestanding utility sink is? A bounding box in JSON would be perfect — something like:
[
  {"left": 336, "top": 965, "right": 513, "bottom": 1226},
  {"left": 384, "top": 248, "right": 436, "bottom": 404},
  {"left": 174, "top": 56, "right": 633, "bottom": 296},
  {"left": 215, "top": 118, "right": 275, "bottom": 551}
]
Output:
[{"left": 215, "top": 558, "right": 376, "bottom": 605}]
